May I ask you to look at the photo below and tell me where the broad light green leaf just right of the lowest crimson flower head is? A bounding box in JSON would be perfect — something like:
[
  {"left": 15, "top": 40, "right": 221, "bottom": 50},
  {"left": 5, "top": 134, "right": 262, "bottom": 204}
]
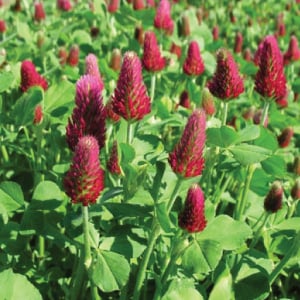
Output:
[{"left": 198, "top": 215, "right": 252, "bottom": 250}]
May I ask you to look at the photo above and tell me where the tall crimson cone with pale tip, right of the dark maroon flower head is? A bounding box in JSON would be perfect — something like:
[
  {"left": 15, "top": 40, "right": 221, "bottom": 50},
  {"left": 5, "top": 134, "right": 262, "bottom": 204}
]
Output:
[{"left": 112, "top": 52, "right": 151, "bottom": 121}]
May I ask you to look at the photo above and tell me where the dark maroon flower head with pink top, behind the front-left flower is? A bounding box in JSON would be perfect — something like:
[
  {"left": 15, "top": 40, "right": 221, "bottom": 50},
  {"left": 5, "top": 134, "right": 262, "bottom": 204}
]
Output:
[{"left": 66, "top": 75, "right": 106, "bottom": 151}]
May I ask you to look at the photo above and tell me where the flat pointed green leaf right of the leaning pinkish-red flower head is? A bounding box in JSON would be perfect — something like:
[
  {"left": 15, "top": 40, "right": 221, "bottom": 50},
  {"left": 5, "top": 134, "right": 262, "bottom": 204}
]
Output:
[{"left": 229, "top": 144, "right": 272, "bottom": 166}]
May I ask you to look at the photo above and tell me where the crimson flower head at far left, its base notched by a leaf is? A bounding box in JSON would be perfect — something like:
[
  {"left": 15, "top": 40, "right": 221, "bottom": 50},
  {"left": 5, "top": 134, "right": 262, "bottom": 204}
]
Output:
[{"left": 20, "top": 60, "right": 48, "bottom": 92}]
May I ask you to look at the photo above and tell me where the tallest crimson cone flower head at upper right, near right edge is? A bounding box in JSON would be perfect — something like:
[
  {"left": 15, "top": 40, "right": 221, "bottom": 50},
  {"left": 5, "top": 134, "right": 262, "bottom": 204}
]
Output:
[{"left": 255, "top": 35, "right": 286, "bottom": 99}]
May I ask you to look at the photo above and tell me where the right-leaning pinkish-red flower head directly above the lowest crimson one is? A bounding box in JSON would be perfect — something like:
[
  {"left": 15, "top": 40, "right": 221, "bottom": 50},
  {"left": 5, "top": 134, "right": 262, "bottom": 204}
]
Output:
[{"left": 168, "top": 109, "right": 206, "bottom": 178}]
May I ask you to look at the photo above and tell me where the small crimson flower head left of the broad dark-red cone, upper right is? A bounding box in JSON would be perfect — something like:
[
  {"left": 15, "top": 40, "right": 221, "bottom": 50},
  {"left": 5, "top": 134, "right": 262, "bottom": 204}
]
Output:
[{"left": 183, "top": 41, "right": 204, "bottom": 76}]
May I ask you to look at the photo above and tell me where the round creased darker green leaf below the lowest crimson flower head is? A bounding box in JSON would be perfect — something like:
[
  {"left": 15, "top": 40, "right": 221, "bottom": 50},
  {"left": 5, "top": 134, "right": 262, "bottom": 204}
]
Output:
[{"left": 182, "top": 239, "right": 222, "bottom": 274}]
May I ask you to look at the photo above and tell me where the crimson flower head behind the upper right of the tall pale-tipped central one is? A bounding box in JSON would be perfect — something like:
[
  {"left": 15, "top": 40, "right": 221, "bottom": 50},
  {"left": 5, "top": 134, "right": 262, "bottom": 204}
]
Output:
[{"left": 142, "top": 31, "right": 166, "bottom": 72}]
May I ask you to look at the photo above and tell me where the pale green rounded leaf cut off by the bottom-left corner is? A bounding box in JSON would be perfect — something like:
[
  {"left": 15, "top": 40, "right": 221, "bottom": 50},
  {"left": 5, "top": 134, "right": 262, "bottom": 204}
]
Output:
[{"left": 0, "top": 269, "right": 42, "bottom": 300}]
